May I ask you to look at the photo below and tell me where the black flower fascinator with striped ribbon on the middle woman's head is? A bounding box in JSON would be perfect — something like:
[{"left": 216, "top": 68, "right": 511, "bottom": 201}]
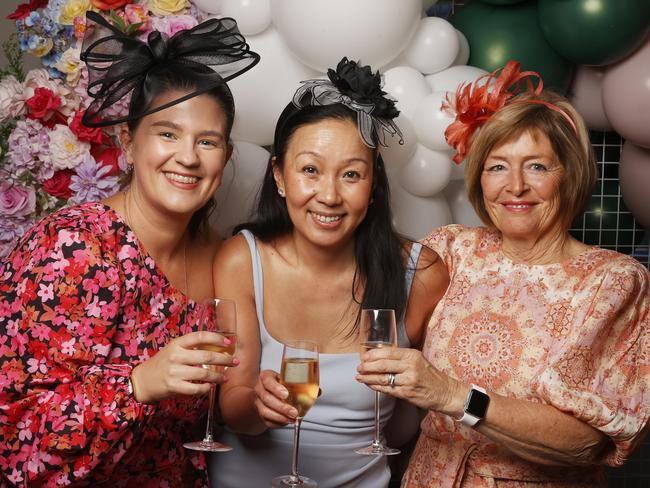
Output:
[{"left": 293, "top": 57, "right": 404, "bottom": 148}]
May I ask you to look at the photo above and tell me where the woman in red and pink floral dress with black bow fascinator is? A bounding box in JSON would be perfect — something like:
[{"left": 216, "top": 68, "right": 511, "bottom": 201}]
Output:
[{"left": 0, "top": 12, "right": 259, "bottom": 487}]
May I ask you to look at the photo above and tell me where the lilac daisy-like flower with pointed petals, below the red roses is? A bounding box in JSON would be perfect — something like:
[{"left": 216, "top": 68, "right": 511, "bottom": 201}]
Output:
[{"left": 69, "top": 155, "right": 119, "bottom": 204}]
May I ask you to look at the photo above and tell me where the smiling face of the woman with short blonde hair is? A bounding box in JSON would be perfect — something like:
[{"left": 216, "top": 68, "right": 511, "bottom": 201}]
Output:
[{"left": 481, "top": 131, "right": 564, "bottom": 240}]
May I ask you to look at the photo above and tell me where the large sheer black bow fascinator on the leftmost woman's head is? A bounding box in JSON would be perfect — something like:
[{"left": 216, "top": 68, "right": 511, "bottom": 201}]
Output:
[{"left": 81, "top": 12, "right": 260, "bottom": 127}]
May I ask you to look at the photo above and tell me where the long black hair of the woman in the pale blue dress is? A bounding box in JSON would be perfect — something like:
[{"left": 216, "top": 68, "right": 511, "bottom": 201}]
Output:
[{"left": 233, "top": 103, "right": 407, "bottom": 326}]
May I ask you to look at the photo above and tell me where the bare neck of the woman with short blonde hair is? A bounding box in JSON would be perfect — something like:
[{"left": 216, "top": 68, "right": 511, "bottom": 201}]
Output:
[{"left": 501, "top": 230, "right": 585, "bottom": 264}]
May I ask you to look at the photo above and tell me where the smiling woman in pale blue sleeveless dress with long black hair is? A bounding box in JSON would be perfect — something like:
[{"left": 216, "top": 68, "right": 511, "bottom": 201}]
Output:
[{"left": 210, "top": 58, "right": 447, "bottom": 488}]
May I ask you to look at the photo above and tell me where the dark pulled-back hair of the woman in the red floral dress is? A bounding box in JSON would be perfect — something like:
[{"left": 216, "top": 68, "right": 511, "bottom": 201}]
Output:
[{"left": 127, "top": 66, "right": 235, "bottom": 239}]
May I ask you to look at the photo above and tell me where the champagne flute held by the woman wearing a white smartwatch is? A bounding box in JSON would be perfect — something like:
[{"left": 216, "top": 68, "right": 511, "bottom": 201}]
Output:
[{"left": 354, "top": 309, "right": 400, "bottom": 456}]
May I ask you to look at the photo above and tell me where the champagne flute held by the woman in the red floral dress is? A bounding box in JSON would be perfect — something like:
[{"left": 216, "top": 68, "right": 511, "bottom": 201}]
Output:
[{"left": 183, "top": 298, "right": 237, "bottom": 452}]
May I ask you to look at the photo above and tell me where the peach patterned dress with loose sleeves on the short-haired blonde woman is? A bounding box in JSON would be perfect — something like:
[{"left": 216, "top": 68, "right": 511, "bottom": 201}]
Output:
[{"left": 402, "top": 225, "right": 650, "bottom": 488}]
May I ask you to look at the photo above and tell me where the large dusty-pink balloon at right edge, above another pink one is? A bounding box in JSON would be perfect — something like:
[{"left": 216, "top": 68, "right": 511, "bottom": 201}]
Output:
[{"left": 603, "top": 37, "right": 650, "bottom": 147}]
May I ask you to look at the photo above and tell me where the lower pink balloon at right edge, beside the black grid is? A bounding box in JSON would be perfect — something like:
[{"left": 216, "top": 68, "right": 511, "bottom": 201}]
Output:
[{"left": 618, "top": 141, "right": 650, "bottom": 229}]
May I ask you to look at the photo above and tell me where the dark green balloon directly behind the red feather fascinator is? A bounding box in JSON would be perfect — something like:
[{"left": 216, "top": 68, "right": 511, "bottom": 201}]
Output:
[{"left": 450, "top": 1, "right": 573, "bottom": 93}]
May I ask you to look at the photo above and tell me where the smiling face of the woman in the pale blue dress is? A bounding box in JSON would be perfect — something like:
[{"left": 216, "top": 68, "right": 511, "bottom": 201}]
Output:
[{"left": 274, "top": 118, "right": 373, "bottom": 247}]
